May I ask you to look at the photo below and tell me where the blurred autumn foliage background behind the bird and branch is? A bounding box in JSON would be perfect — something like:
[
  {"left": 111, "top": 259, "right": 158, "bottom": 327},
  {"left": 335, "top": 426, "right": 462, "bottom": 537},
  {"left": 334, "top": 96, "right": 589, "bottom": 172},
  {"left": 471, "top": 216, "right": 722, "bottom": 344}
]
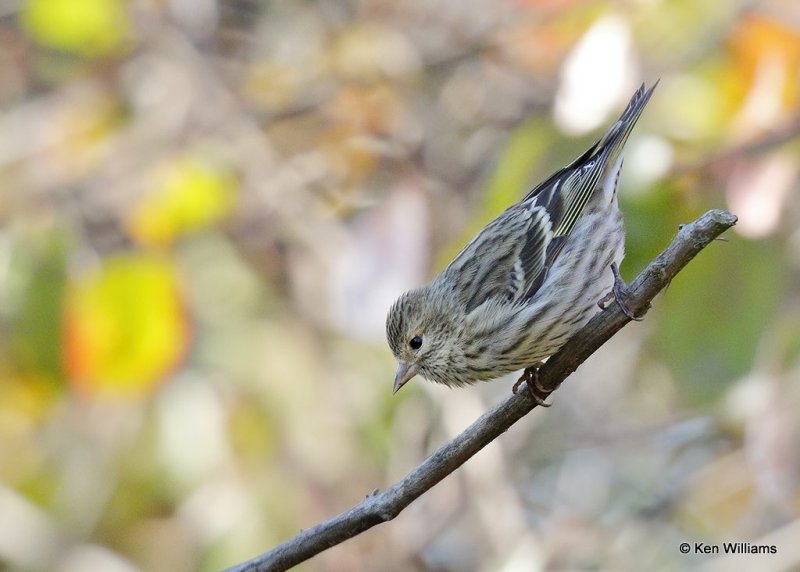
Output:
[{"left": 0, "top": 0, "right": 800, "bottom": 572}]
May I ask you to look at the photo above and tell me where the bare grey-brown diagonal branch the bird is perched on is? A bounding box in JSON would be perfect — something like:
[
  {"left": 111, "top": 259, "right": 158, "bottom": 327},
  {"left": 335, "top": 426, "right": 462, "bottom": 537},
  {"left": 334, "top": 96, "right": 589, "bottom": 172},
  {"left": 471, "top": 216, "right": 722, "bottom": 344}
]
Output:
[{"left": 227, "top": 210, "right": 736, "bottom": 572}]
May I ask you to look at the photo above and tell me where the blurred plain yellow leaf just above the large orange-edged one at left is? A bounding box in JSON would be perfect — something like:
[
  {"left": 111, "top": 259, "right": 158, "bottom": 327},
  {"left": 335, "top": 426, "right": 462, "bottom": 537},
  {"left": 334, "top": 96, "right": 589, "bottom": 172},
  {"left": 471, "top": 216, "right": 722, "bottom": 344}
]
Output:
[{"left": 128, "top": 157, "right": 236, "bottom": 245}]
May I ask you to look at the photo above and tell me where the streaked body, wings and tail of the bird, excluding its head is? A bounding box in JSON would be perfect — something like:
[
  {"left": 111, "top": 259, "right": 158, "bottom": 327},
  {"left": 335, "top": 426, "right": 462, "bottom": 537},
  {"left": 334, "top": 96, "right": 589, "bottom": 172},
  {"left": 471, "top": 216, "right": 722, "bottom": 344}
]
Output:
[{"left": 443, "top": 86, "right": 655, "bottom": 379}]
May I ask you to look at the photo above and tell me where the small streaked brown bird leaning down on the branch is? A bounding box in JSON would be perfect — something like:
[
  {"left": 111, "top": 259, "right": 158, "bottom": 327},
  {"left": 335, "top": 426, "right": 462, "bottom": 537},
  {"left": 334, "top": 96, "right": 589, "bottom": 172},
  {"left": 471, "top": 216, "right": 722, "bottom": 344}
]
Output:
[{"left": 386, "top": 82, "right": 658, "bottom": 405}]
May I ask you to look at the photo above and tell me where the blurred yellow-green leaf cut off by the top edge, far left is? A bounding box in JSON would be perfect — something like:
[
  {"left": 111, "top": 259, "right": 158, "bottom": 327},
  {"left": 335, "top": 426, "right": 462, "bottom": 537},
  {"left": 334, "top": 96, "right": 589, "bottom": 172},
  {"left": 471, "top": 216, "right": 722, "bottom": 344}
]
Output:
[{"left": 22, "top": 0, "right": 130, "bottom": 56}]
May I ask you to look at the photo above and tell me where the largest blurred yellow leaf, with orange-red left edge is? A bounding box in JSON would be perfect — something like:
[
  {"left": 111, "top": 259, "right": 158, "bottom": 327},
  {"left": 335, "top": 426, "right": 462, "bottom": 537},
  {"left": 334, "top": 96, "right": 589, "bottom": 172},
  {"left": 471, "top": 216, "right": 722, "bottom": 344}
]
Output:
[{"left": 64, "top": 255, "right": 189, "bottom": 397}]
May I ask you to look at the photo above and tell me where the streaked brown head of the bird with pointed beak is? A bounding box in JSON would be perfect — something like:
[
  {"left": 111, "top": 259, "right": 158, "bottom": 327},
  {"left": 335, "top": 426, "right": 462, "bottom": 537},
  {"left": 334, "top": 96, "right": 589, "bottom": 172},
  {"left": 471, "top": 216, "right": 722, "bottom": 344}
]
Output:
[{"left": 386, "top": 286, "right": 455, "bottom": 393}]
